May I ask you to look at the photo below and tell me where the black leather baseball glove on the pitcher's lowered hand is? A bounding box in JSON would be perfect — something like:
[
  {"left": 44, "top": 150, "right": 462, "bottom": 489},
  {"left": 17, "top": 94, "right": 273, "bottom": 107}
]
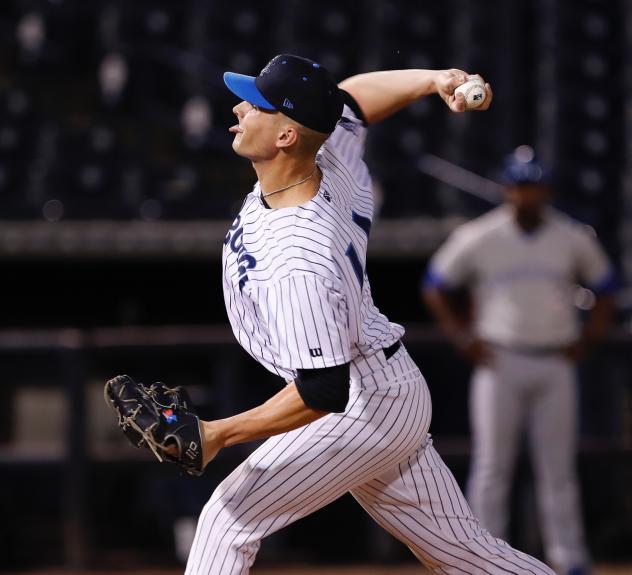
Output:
[{"left": 104, "top": 375, "right": 204, "bottom": 475}]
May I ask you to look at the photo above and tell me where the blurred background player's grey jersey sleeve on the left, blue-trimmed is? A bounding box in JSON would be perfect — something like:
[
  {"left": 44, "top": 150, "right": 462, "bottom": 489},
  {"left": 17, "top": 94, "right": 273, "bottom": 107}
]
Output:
[{"left": 424, "top": 228, "right": 475, "bottom": 289}]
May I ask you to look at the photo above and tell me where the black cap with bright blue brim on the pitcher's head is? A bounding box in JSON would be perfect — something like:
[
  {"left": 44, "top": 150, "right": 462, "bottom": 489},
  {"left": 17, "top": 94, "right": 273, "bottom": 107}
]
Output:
[{"left": 224, "top": 54, "right": 343, "bottom": 134}]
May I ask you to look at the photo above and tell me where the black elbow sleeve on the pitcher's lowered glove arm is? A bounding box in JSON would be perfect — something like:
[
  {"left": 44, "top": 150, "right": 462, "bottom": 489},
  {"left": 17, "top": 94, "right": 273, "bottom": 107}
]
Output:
[{"left": 294, "top": 363, "right": 350, "bottom": 413}]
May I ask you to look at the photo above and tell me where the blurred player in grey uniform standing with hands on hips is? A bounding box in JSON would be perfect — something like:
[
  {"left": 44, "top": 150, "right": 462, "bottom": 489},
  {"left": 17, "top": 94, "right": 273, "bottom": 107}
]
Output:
[{"left": 424, "top": 146, "right": 614, "bottom": 575}]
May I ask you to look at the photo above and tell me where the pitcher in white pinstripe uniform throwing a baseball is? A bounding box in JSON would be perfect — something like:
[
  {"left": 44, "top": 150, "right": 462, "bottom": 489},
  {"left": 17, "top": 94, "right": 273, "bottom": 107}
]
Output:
[{"left": 106, "top": 54, "right": 552, "bottom": 575}]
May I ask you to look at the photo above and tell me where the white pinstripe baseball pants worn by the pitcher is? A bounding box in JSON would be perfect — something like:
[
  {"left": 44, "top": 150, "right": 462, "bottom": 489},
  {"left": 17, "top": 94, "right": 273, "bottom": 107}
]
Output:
[{"left": 186, "top": 346, "right": 553, "bottom": 575}]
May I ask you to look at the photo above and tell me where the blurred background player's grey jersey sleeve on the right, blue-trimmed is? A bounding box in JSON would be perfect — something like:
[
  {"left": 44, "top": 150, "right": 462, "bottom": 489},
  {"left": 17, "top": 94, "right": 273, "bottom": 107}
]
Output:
[{"left": 574, "top": 226, "right": 616, "bottom": 295}]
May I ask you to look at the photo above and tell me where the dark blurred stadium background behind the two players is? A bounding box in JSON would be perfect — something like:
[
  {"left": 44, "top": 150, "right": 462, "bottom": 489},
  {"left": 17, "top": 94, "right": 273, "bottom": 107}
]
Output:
[{"left": 0, "top": 0, "right": 632, "bottom": 572}]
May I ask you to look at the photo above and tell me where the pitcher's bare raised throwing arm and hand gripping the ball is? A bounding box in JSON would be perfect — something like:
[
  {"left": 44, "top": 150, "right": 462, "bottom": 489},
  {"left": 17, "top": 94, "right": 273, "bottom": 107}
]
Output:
[{"left": 340, "top": 68, "right": 492, "bottom": 124}]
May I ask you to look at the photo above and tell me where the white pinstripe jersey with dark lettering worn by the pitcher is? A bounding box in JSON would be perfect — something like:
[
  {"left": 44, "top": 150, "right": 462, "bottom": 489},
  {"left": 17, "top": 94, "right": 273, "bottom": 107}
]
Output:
[{"left": 222, "top": 106, "right": 404, "bottom": 379}]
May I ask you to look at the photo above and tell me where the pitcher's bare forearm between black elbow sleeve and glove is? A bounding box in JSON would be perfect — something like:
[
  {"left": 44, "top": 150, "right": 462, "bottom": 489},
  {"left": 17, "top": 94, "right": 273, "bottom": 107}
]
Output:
[{"left": 202, "top": 382, "right": 329, "bottom": 465}]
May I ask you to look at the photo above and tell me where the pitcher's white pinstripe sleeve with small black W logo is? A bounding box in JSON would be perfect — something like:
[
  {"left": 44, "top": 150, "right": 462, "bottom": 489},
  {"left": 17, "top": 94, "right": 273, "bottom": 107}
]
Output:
[{"left": 264, "top": 275, "right": 351, "bottom": 370}]
